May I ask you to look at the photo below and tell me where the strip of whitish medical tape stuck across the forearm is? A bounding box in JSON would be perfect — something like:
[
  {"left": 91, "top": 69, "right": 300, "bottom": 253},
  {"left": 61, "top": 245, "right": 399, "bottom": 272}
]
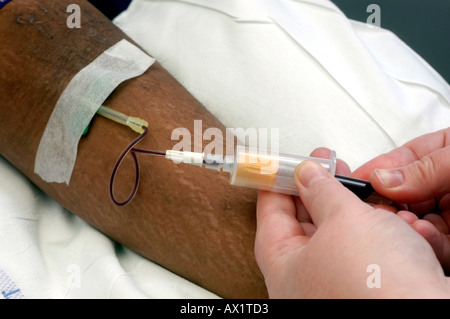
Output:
[{"left": 34, "top": 40, "right": 155, "bottom": 184}]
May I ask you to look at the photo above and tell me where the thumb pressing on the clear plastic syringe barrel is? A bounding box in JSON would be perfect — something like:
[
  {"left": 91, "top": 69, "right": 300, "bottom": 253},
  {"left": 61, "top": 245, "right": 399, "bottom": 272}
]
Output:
[{"left": 295, "top": 161, "right": 370, "bottom": 227}]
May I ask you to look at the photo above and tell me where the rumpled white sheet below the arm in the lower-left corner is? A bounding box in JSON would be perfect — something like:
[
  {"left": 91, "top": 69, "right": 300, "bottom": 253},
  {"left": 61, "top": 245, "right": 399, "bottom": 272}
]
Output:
[{"left": 0, "top": 157, "right": 217, "bottom": 299}]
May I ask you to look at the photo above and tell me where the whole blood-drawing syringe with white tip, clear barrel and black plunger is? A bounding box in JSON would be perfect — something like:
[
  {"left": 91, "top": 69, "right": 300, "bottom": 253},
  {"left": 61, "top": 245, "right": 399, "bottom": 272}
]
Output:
[{"left": 165, "top": 145, "right": 392, "bottom": 205}]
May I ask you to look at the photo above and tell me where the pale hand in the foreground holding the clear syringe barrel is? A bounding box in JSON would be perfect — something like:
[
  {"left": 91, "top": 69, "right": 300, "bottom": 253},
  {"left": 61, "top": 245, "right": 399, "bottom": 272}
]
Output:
[{"left": 255, "top": 161, "right": 449, "bottom": 298}]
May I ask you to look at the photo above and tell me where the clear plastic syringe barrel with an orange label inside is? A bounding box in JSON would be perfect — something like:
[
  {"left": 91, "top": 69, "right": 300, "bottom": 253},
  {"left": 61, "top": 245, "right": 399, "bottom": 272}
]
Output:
[{"left": 230, "top": 146, "right": 336, "bottom": 195}]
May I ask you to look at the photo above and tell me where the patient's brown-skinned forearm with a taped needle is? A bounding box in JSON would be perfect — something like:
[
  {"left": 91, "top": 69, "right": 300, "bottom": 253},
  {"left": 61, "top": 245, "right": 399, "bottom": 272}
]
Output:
[{"left": 0, "top": 0, "right": 266, "bottom": 298}]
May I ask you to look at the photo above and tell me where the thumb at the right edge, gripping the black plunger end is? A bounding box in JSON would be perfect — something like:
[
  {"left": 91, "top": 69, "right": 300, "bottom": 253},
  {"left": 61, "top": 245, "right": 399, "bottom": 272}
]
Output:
[{"left": 370, "top": 146, "right": 450, "bottom": 203}]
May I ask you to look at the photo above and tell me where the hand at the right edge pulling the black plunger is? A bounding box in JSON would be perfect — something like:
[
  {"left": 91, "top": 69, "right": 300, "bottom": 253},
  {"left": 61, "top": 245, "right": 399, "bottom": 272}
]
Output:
[{"left": 352, "top": 128, "right": 450, "bottom": 270}]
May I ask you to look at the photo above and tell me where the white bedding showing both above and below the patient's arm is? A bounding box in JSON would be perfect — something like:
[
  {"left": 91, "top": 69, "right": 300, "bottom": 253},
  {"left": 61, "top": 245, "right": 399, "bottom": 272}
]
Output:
[{"left": 0, "top": 0, "right": 450, "bottom": 299}]
